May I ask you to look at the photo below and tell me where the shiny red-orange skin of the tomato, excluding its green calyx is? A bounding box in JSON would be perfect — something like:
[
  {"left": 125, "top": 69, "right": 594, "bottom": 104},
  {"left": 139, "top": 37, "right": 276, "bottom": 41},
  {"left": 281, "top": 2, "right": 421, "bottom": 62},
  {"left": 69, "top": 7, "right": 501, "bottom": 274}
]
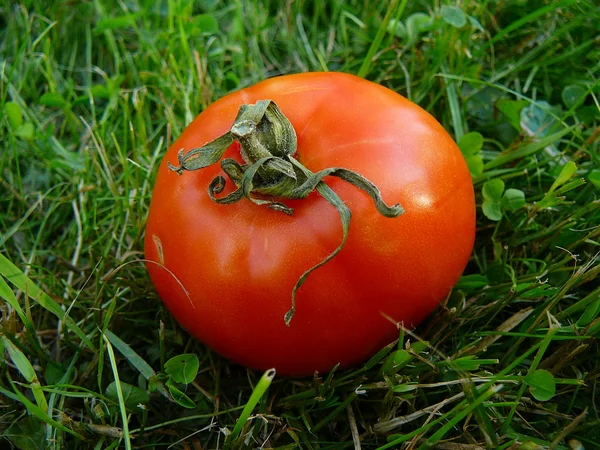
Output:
[{"left": 145, "top": 72, "right": 475, "bottom": 376}]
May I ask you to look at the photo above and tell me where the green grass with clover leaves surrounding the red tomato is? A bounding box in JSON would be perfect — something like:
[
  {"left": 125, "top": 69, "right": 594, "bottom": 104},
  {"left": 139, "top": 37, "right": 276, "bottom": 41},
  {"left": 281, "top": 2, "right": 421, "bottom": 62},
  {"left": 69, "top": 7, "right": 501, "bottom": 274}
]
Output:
[{"left": 0, "top": 0, "right": 600, "bottom": 450}]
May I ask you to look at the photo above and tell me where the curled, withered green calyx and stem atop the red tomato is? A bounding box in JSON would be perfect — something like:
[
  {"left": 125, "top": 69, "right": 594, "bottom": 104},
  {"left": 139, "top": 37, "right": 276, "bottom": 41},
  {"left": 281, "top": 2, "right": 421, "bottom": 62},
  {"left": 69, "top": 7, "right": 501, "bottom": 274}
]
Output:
[{"left": 168, "top": 100, "right": 404, "bottom": 326}]
